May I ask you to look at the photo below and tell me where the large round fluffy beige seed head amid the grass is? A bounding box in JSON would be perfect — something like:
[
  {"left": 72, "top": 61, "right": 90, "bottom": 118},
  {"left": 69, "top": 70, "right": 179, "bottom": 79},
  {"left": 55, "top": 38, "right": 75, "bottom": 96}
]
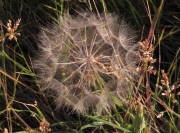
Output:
[{"left": 33, "top": 12, "right": 138, "bottom": 113}]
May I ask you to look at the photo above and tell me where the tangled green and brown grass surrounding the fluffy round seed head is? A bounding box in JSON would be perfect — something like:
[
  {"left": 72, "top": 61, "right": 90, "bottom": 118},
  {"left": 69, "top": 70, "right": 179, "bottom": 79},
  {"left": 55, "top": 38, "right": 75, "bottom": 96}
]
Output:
[{"left": 0, "top": 0, "right": 180, "bottom": 133}]
